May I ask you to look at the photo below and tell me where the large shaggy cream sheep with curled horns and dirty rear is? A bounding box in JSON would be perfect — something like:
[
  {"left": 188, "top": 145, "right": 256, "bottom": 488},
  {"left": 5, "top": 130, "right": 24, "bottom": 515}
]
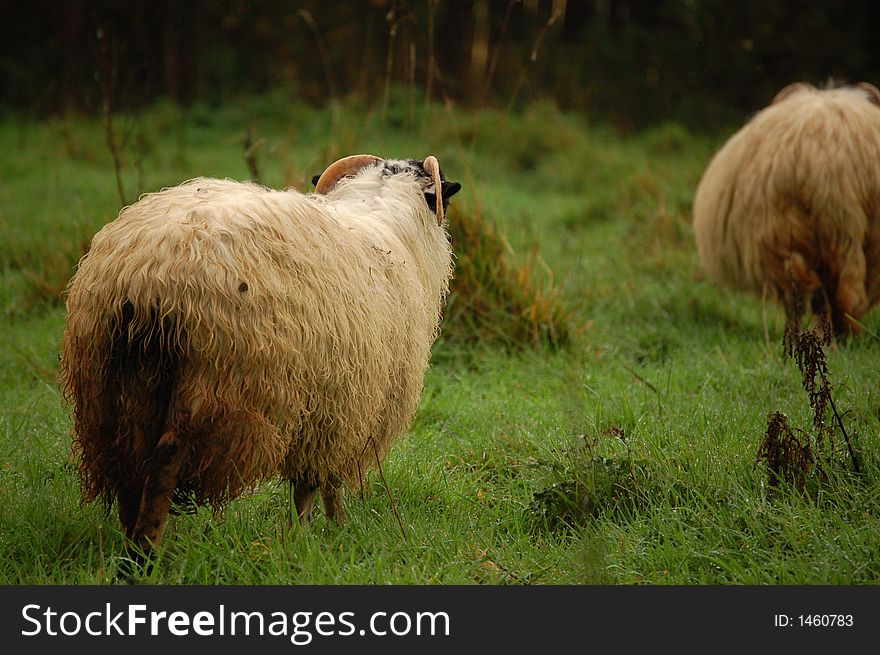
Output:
[{"left": 59, "top": 155, "right": 461, "bottom": 557}]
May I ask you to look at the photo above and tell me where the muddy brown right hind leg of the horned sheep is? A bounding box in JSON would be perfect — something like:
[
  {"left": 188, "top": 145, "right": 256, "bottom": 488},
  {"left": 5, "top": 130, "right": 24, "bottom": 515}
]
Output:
[{"left": 131, "top": 430, "right": 183, "bottom": 554}]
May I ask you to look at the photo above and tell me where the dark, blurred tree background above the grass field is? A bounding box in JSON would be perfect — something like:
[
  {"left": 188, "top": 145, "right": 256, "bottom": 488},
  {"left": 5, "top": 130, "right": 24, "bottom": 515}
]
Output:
[{"left": 0, "top": 0, "right": 880, "bottom": 127}]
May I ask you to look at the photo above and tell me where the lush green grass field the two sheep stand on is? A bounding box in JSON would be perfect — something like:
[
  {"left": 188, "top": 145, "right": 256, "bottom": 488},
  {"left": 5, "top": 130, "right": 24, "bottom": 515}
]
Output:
[{"left": 0, "top": 95, "right": 880, "bottom": 584}]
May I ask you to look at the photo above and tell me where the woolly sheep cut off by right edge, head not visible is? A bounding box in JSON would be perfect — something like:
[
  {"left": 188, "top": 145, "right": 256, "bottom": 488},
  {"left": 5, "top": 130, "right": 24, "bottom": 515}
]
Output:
[{"left": 693, "top": 82, "right": 880, "bottom": 335}]
